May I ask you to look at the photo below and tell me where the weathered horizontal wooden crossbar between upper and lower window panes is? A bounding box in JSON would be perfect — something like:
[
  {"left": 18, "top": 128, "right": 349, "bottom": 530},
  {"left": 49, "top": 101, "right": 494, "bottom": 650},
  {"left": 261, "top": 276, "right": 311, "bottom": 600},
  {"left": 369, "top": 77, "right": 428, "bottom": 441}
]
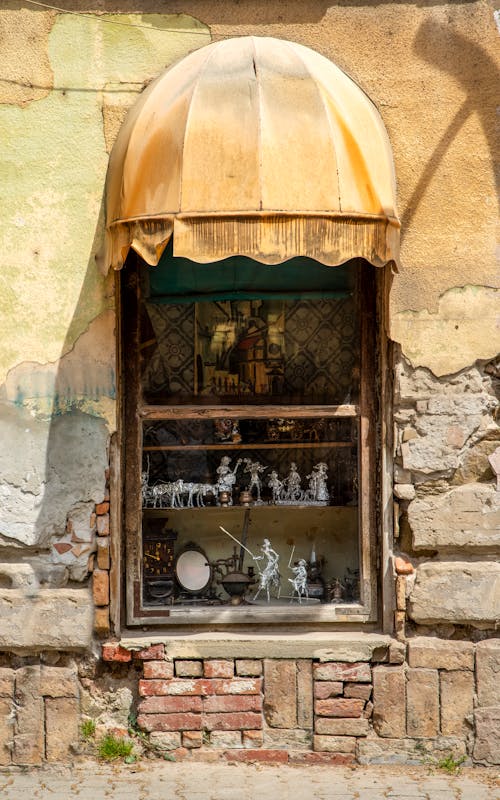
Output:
[{"left": 138, "top": 405, "right": 359, "bottom": 420}]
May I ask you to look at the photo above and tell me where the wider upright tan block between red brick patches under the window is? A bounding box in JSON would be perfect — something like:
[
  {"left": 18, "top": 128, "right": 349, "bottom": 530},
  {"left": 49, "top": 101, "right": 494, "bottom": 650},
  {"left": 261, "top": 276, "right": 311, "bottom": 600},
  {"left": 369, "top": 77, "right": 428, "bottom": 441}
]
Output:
[{"left": 264, "top": 658, "right": 297, "bottom": 728}]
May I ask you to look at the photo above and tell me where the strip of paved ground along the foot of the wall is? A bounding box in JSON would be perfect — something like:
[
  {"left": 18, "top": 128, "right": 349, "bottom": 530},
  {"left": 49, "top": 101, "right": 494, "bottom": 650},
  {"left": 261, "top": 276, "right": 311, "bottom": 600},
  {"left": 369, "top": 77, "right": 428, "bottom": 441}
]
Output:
[{"left": 0, "top": 761, "right": 500, "bottom": 800}]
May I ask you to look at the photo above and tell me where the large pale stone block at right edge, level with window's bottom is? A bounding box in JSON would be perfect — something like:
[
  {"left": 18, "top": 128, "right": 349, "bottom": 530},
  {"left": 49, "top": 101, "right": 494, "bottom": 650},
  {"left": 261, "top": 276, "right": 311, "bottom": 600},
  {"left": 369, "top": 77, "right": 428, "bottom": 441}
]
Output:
[{"left": 408, "top": 561, "right": 500, "bottom": 627}]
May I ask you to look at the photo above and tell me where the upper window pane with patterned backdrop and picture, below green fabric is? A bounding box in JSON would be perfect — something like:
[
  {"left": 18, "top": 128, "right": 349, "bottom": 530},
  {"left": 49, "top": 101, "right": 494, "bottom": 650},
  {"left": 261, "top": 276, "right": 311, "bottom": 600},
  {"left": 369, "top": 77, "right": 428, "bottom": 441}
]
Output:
[{"left": 141, "top": 294, "right": 359, "bottom": 404}]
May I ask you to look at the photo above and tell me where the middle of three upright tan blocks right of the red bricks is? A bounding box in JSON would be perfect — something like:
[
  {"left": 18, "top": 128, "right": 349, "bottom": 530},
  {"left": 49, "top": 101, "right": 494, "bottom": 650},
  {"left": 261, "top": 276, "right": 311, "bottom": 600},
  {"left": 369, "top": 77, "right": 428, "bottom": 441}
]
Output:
[{"left": 406, "top": 669, "right": 439, "bottom": 738}]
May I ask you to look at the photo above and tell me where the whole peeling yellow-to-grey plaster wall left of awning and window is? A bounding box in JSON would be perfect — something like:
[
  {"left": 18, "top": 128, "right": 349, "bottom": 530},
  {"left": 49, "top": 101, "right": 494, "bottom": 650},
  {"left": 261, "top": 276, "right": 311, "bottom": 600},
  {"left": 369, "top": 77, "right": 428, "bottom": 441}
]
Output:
[{"left": 0, "top": 4, "right": 209, "bottom": 636}]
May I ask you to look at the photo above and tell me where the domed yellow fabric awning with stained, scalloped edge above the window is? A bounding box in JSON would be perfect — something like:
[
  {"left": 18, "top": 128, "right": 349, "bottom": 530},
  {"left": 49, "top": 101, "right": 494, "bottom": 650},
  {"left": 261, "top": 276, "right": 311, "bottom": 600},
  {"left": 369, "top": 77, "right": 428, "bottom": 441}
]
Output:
[{"left": 107, "top": 37, "right": 399, "bottom": 269}]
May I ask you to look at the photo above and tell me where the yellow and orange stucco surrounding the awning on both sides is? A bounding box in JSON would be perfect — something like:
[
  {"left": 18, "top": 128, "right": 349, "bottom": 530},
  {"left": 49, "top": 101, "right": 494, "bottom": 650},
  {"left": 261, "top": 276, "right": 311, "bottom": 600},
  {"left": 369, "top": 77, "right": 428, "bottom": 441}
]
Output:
[{"left": 0, "top": 0, "right": 500, "bottom": 385}]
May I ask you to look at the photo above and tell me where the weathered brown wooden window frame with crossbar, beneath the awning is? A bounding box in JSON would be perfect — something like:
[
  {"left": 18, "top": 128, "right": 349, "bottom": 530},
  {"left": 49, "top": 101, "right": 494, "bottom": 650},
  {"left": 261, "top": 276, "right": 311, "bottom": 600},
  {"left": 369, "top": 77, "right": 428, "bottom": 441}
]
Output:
[{"left": 118, "top": 251, "right": 387, "bottom": 630}]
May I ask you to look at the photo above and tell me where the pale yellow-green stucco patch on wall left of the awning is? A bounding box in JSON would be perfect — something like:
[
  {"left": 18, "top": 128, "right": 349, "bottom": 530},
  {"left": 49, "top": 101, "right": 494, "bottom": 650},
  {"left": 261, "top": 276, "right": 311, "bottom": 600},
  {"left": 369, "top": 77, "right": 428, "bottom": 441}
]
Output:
[{"left": 0, "top": 11, "right": 209, "bottom": 398}]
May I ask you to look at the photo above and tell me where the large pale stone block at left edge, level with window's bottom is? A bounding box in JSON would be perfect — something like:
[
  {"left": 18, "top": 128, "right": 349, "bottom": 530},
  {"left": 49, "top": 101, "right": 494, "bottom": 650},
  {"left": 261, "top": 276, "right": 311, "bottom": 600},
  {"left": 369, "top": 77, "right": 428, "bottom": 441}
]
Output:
[{"left": 0, "top": 587, "right": 93, "bottom": 652}]
